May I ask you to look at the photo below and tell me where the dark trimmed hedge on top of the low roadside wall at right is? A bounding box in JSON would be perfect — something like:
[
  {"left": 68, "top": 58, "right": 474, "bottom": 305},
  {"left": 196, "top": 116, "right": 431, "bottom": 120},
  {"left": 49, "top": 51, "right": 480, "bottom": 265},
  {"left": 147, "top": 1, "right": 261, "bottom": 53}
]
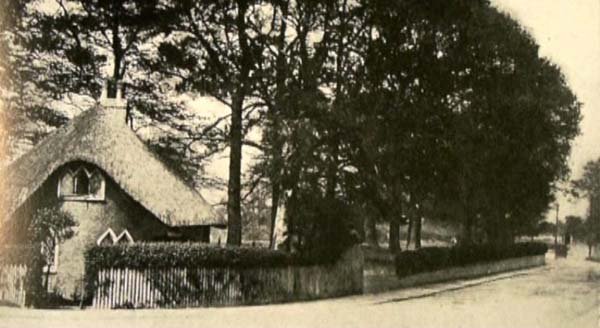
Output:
[{"left": 395, "top": 242, "right": 548, "bottom": 277}]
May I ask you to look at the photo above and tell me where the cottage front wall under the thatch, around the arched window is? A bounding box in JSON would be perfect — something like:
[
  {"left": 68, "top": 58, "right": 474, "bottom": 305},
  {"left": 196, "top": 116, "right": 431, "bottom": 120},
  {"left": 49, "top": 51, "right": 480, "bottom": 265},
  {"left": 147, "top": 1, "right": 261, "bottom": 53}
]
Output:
[{"left": 3, "top": 164, "right": 180, "bottom": 299}]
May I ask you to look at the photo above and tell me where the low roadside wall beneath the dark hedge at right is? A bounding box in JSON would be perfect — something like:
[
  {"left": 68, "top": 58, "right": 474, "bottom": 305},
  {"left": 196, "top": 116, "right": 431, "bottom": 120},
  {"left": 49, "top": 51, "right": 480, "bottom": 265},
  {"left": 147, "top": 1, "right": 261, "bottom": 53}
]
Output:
[{"left": 364, "top": 255, "right": 545, "bottom": 293}]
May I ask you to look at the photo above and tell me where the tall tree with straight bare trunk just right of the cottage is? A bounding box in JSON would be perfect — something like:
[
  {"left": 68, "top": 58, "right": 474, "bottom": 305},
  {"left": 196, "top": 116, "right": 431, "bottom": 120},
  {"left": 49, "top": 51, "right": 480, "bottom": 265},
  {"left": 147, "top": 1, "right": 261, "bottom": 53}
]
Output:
[{"left": 159, "top": 0, "right": 261, "bottom": 245}]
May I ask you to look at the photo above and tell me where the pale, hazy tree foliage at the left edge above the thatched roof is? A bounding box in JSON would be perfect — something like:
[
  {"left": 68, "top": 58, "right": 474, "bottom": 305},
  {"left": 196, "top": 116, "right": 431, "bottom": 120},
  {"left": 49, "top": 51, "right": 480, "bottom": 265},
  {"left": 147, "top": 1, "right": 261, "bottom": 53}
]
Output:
[{"left": 0, "top": 0, "right": 72, "bottom": 161}]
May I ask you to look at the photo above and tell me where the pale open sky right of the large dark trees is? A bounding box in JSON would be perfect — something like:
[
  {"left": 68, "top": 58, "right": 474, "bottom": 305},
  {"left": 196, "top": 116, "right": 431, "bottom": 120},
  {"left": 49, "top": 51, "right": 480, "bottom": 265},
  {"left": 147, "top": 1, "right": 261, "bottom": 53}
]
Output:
[{"left": 492, "top": 0, "right": 600, "bottom": 218}]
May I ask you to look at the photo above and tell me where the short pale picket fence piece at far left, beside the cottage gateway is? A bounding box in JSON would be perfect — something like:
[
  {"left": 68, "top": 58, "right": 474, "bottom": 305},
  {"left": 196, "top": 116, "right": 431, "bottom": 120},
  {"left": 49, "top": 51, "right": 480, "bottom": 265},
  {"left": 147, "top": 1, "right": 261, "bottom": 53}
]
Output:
[{"left": 0, "top": 264, "right": 27, "bottom": 307}]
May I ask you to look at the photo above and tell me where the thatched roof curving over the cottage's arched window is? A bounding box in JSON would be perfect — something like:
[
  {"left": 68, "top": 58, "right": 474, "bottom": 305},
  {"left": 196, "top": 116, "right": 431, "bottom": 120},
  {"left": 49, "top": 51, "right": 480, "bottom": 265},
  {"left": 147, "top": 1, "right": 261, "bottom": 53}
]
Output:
[{"left": 0, "top": 105, "right": 225, "bottom": 226}]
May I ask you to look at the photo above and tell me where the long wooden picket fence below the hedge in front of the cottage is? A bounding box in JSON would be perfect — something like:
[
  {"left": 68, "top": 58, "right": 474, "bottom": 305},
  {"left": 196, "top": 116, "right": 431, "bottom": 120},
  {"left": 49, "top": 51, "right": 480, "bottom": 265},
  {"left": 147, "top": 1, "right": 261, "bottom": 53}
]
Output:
[{"left": 92, "top": 247, "right": 363, "bottom": 308}]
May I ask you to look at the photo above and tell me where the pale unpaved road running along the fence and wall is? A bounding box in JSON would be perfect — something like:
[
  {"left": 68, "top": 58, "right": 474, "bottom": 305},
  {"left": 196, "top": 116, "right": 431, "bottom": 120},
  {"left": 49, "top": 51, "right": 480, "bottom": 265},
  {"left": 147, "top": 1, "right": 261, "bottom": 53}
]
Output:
[{"left": 0, "top": 245, "right": 600, "bottom": 328}]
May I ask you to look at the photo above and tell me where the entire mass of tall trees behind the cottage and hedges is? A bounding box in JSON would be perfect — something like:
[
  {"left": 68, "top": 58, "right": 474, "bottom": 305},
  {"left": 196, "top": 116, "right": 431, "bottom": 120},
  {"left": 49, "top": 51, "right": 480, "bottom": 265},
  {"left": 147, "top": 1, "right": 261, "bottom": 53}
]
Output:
[{"left": 0, "top": 0, "right": 581, "bottom": 252}]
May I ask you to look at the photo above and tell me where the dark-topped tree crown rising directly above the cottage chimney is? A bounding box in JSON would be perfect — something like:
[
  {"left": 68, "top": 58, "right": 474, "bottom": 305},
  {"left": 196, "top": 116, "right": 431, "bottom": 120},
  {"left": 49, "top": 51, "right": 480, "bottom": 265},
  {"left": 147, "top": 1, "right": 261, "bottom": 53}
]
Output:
[{"left": 35, "top": 0, "right": 165, "bottom": 97}]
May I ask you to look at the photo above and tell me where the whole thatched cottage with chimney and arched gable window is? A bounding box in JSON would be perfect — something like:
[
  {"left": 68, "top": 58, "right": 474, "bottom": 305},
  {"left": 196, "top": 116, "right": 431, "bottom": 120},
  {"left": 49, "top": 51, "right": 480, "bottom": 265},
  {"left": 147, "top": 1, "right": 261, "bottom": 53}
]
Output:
[{"left": 0, "top": 85, "right": 225, "bottom": 298}]
